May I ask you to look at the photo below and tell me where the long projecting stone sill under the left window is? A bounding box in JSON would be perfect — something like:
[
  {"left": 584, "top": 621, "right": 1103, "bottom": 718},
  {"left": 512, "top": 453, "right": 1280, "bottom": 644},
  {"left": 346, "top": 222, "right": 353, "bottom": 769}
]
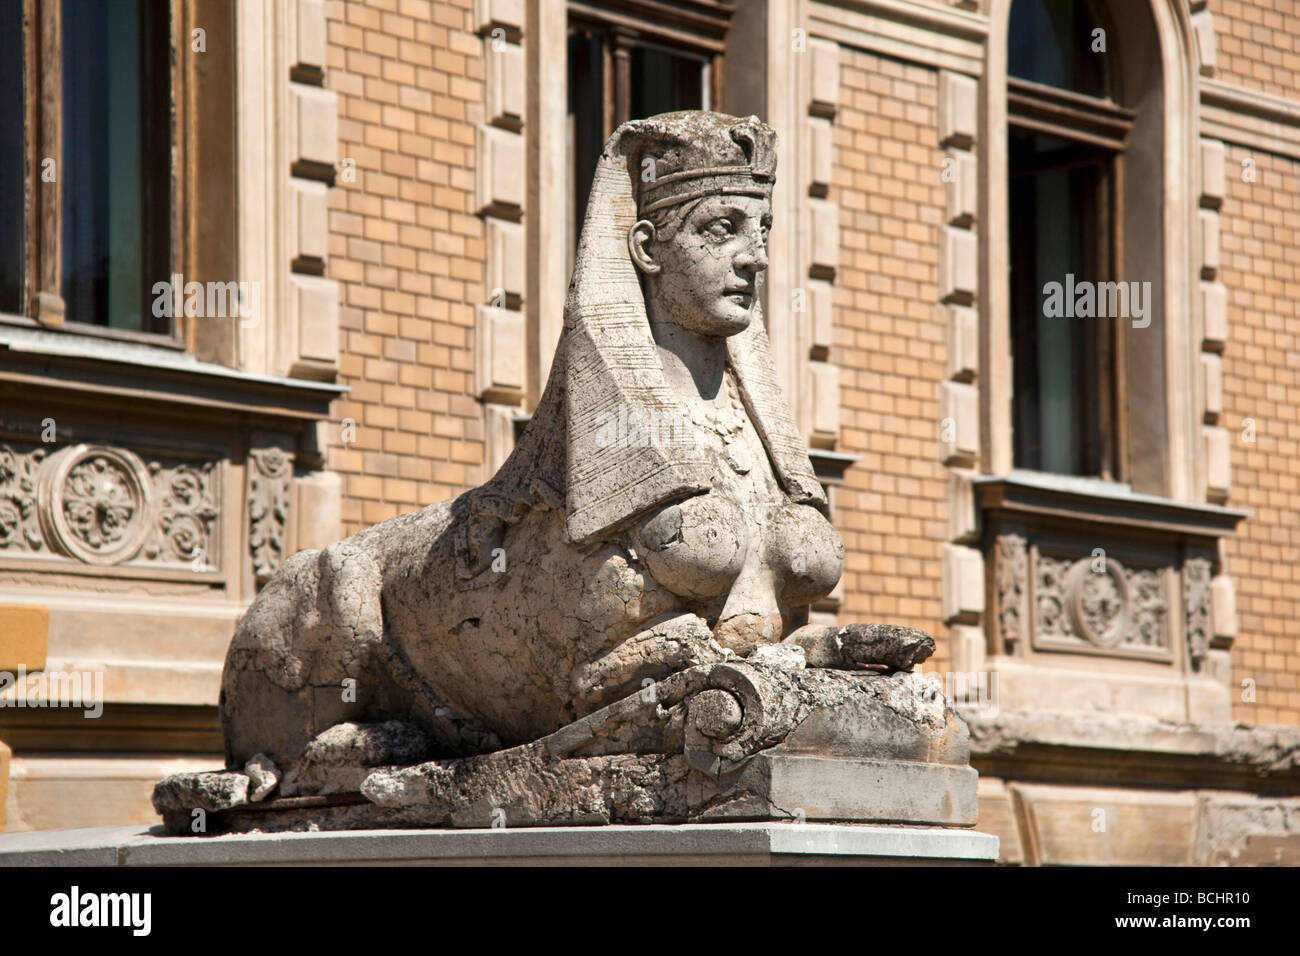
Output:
[{"left": 0, "top": 324, "right": 350, "bottom": 420}]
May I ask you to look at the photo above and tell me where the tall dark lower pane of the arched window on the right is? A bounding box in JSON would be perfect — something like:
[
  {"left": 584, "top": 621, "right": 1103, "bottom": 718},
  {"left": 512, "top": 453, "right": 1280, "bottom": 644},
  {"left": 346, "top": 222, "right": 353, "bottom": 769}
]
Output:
[{"left": 1010, "top": 130, "right": 1110, "bottom": 475}]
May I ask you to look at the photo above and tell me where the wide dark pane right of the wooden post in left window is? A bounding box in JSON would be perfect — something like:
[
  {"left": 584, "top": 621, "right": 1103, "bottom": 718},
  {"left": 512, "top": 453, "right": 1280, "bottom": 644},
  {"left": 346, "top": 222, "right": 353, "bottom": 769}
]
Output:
[{"left": 60, "top": 0, "right": 172, "bottom": 332}]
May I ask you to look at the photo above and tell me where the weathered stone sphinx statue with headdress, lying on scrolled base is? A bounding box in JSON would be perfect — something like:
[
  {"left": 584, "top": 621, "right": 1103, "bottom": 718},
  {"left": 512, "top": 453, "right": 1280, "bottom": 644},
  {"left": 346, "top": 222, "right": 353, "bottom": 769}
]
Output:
[{"left": 155, "top": 112, "right": 975, "bottom": 831}]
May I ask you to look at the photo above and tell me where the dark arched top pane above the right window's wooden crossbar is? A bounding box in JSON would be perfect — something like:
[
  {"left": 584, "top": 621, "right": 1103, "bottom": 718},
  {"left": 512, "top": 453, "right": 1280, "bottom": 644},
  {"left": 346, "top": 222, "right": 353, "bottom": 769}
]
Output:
[{"left": 1006, "top": 0, "right": 1115, "bottom": 96}]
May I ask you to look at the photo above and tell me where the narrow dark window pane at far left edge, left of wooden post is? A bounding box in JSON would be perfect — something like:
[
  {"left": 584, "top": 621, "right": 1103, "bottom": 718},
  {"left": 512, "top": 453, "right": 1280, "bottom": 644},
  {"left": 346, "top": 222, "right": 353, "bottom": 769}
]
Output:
[{"left": 0, "top": 0, "right": 26, "bottom": 312}]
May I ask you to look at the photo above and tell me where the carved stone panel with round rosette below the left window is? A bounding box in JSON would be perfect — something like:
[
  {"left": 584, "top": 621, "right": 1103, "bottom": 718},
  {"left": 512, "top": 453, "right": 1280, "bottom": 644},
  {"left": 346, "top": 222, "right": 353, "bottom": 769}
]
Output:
[{"left": 0, "top": 445, "right": 221, "bottom": 571}]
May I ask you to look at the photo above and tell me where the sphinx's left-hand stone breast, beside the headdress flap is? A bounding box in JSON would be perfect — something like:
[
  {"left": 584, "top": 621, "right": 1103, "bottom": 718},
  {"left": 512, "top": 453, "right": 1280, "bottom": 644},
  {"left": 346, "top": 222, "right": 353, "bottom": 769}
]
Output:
[{"left": 638, "top": 494, "right": 750, "bottom": 598}]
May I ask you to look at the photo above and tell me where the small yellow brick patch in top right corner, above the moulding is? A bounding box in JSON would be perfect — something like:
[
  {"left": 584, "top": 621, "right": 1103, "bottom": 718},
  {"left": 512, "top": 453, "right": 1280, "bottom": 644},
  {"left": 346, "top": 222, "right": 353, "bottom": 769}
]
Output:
[{"left": 1208, "top": 0, "right": 1300, "bottom": 99}]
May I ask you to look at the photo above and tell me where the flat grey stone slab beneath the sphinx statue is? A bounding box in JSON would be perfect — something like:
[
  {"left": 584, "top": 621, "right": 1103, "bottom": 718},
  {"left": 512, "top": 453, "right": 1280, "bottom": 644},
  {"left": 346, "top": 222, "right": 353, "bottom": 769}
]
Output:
[{"left": 0, "top": 823, "right": 998, "bottom": 868}]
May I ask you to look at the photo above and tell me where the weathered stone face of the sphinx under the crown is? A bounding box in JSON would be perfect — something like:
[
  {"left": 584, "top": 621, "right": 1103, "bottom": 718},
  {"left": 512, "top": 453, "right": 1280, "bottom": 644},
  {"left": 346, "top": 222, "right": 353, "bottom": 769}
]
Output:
[{"left": 649, "top": 195, "right": 772, "bottom": 338}]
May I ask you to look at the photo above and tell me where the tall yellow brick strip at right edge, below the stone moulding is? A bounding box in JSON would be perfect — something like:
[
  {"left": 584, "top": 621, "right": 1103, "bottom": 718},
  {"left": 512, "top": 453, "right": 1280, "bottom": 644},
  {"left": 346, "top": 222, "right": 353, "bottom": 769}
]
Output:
[{"left": 1221, "top": 146, "right": 1300, "bottom": 724}]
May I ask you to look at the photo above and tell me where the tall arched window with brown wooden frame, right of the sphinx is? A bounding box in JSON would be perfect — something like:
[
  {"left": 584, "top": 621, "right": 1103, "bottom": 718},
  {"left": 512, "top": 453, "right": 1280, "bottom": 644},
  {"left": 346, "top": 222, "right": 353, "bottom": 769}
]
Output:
[{"left": 1008, "top": 0, "right": 1134, "bottom": 480}]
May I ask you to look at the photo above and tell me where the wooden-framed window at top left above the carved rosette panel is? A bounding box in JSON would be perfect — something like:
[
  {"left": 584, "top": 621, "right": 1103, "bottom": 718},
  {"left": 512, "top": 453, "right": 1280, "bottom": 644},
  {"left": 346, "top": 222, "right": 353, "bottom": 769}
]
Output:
[{"left": 0, "top": 0, "right": 174, "bottom": 336}]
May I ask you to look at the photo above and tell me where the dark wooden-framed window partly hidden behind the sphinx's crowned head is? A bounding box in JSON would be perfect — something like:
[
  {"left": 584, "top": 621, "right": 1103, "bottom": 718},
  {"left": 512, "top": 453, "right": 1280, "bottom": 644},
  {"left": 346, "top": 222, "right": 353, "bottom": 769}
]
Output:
[{"left": 568, "top": 0, "right": 731, "bottom": 260}]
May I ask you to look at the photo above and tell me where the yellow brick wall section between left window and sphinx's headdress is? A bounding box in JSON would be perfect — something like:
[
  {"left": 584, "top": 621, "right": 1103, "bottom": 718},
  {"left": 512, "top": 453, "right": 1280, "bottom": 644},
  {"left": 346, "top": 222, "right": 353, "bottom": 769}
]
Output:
[{"left": 326, "top": 0, "right": 485, "bottom": 533}]
